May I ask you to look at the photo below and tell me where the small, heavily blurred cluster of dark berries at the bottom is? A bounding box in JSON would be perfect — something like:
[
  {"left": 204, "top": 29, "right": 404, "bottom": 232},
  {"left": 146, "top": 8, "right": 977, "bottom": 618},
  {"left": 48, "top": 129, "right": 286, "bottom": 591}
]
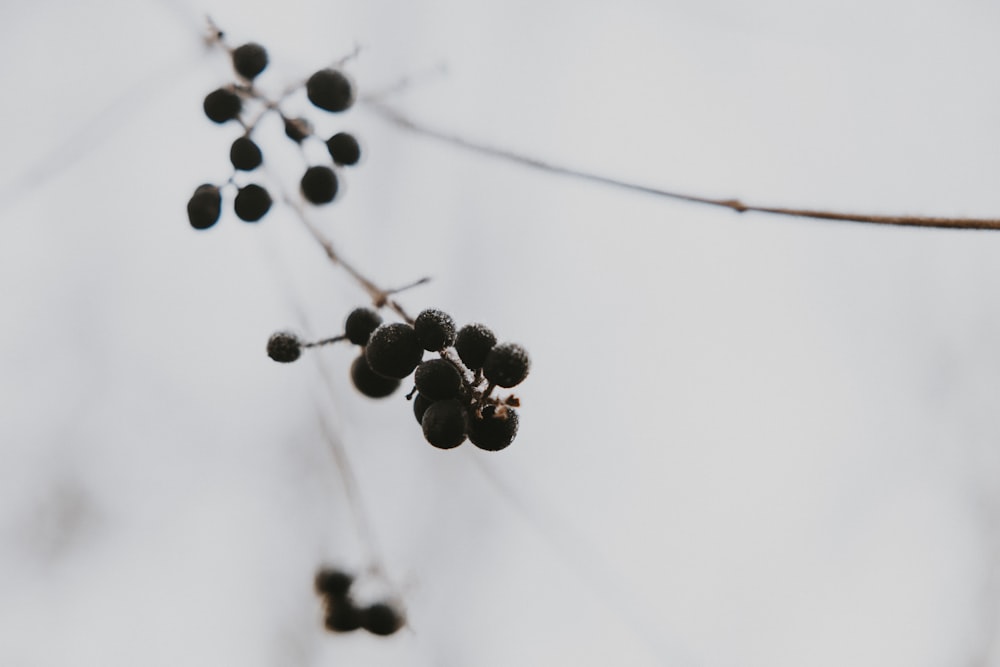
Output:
[{"left": 315, "top": 569, "right": 406, "bottom": 637}]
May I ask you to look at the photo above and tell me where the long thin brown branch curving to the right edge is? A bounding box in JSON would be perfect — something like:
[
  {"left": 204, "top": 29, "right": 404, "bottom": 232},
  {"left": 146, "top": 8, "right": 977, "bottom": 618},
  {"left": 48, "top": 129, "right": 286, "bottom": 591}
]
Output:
[{"left": 364, "top": 98, "right": 1000, "bottom": 230}]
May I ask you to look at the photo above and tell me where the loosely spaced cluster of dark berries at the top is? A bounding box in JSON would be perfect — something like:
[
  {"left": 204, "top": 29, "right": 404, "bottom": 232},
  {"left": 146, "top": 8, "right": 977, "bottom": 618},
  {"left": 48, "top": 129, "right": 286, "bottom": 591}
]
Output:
[{"left": 188, "top": 34, "right": 361, "bottom": 229}]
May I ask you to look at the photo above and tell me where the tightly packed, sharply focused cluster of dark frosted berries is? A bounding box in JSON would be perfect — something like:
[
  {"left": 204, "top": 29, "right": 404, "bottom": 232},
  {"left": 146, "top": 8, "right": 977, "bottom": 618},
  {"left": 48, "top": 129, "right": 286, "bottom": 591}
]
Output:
[{"left": 267, "top": 308, "right": 531, "bottom": 451}]
